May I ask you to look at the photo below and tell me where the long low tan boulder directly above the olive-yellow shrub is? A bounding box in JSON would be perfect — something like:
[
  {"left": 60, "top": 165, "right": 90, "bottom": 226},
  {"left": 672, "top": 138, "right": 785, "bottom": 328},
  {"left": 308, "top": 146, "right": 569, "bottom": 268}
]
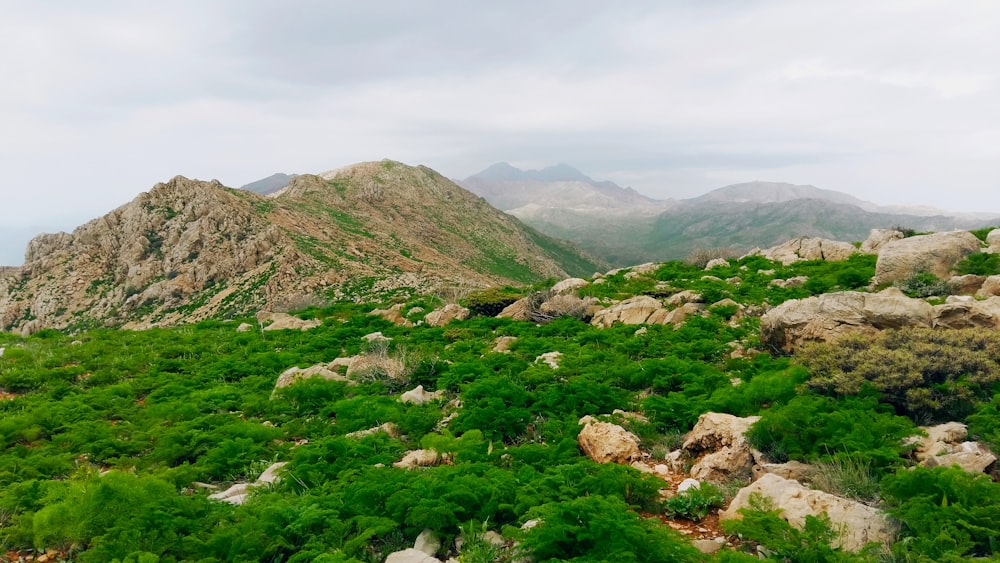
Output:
[{"left": 760, "top": 288, "right": 934, "bottom": 352}]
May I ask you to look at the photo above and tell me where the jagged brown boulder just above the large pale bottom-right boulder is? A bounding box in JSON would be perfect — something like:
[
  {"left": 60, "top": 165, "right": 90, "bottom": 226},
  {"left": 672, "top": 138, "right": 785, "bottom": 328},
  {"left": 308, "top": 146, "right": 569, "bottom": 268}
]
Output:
[{"left": 681, "top": 412, "right": 760, "bottom": 481}]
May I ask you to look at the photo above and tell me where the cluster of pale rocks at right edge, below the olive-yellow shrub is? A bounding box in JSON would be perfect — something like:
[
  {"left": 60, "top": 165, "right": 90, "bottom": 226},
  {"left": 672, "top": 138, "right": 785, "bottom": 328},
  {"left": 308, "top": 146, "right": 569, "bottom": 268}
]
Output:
[{"left": 913, "top": 422, "right": 997, "bottom": 473}]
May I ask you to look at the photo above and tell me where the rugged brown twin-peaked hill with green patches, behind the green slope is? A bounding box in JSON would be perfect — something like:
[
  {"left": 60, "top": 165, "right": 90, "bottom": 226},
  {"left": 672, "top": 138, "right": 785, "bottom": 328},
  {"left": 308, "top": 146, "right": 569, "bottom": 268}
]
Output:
[{"left": 0, "top": 161, "right": 599, "bottom": 332}]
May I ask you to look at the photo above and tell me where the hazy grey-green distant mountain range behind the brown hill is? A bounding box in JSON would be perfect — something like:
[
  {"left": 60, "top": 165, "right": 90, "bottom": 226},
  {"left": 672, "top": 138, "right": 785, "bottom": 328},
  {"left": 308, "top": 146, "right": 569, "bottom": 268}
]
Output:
[{"left": 458, "top": 163, "right": 1000, "bottom": 266}]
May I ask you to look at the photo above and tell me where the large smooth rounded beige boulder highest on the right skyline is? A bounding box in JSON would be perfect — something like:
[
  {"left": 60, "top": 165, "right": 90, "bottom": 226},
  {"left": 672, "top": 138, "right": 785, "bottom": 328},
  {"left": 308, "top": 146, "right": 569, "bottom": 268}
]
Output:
[{"left": 873, "top": 231, "right": 979, "bottom": 284}]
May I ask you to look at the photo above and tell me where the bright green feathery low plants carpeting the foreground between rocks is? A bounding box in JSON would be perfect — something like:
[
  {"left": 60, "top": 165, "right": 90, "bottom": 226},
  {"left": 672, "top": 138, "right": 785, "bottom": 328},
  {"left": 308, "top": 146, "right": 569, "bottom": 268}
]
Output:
[{"left": 0, "top": 256, "right": 1000, "bottom": 562}]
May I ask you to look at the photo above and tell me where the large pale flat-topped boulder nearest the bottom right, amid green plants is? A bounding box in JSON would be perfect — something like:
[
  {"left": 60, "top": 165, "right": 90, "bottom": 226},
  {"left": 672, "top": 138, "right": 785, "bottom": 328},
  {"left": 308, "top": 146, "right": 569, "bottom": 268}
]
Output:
[{"left": 719, "top": 474, "right": 893, "bottom": 551}]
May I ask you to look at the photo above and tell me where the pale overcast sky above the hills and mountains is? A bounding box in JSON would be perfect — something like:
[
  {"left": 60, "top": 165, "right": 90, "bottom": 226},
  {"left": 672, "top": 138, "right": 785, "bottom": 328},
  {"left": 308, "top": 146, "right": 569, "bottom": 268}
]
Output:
[{"left": 0, "top": 0, "right": 1000, "bottom": 265}]
